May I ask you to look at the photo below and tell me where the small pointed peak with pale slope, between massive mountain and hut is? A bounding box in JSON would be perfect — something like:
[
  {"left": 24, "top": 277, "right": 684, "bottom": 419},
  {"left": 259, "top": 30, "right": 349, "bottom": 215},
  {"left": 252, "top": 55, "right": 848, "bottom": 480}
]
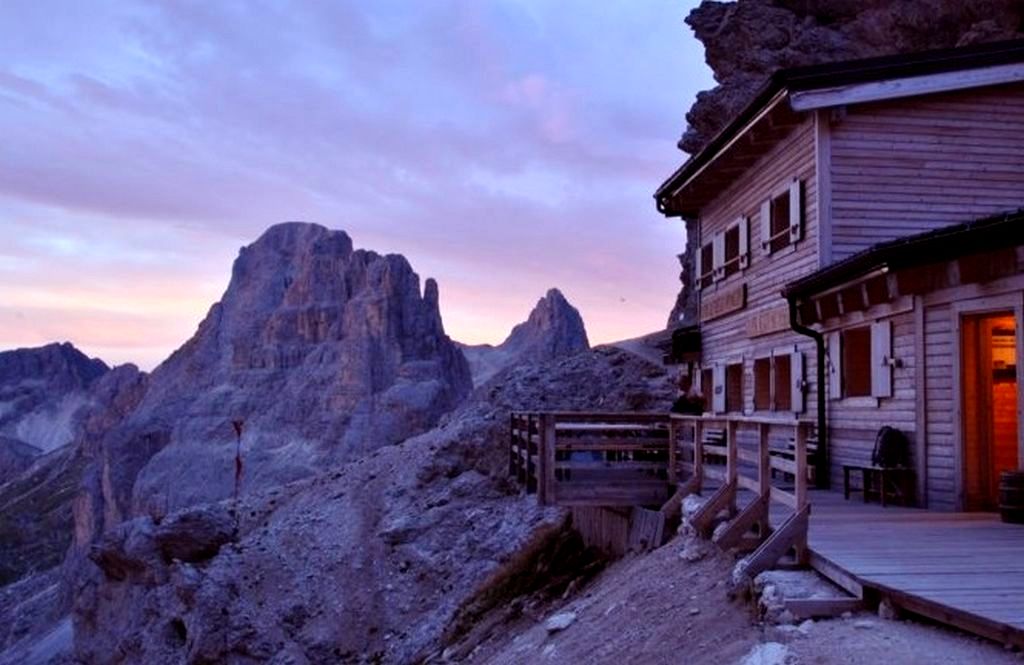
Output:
[{"left": 461, "top": 289, "right": 590, "bottom": 385}]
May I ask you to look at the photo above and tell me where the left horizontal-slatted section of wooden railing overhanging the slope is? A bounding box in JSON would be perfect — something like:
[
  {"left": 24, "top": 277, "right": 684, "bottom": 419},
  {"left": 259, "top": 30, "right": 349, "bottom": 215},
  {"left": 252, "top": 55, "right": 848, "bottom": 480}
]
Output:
[{"left": 509, "top": 412, "right": 675, "bottom": 506}]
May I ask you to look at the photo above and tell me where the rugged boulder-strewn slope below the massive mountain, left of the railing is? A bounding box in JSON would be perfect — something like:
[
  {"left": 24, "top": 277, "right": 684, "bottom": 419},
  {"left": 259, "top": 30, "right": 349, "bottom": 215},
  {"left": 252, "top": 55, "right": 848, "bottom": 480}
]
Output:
[{"left": 68, "top": 348, "right": 674, "bottom": 663}]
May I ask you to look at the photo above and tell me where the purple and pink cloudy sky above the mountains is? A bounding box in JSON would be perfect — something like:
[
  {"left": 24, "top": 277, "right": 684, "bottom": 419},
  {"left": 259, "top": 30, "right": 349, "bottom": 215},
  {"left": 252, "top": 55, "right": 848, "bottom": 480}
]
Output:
[{"left": 0, "top": 0, "right": 714, "bottom": 369}]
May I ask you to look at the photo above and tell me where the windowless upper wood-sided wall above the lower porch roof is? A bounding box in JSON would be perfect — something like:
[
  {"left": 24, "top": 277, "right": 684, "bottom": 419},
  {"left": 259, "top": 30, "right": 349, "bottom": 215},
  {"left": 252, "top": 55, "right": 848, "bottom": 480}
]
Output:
[{"left": 829, "top": 84, "right": 1024, "bottom": 260}]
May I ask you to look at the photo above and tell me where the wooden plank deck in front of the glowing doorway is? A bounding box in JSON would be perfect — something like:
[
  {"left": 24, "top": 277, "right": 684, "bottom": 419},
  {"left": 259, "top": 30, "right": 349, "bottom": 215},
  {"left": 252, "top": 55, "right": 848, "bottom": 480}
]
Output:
[{"left": 786, "top": 492, "right": 1024, "bottom": 648}]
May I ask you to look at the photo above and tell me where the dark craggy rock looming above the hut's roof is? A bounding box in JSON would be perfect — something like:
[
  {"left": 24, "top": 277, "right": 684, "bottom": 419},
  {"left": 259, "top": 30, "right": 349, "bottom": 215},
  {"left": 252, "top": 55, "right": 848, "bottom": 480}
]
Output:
[{"left": 679, "top": 0, "right": 1024, "bottom": 154}]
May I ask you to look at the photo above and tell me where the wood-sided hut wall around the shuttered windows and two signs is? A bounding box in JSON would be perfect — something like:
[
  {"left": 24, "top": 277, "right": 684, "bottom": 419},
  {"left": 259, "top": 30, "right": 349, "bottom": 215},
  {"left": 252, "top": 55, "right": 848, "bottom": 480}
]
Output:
[{"left": 700, "top": 117, "right": 819, "bottom": 419}]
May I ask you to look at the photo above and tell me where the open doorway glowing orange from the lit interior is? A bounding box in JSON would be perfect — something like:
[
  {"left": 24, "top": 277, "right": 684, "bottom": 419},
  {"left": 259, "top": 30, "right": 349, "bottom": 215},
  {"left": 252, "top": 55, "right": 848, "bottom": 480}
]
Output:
[{"left": 961, "top": 311, "right": 1018, "bottom": 510}]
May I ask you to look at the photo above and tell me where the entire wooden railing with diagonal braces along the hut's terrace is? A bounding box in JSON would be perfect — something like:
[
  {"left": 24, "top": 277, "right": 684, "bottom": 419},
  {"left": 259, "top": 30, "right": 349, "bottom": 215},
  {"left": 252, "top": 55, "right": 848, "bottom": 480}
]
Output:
[{"left": 509, "top": 412, "right": 816, "bottom": 576}]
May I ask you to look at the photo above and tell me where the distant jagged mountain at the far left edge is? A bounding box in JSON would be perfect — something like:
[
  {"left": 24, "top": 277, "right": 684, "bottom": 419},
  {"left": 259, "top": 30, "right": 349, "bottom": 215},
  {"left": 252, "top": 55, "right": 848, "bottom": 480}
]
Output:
[{"left": 0, "top": 342, "right": 110, "bottom": 467}]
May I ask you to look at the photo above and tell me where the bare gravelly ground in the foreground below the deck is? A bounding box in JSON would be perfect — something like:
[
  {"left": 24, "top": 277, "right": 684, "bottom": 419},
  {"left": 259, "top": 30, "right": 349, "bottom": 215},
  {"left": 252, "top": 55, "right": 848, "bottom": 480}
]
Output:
[{"left": 466, "top": 538, "right": 1024, "bottom": 665}]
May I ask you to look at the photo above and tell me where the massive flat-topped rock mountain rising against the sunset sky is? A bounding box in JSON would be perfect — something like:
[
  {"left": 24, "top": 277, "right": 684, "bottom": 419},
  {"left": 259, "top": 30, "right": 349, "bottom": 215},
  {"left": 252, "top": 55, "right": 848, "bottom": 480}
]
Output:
[{"left": 72, "top": 222, "right": 471, "bottom": 560}]
